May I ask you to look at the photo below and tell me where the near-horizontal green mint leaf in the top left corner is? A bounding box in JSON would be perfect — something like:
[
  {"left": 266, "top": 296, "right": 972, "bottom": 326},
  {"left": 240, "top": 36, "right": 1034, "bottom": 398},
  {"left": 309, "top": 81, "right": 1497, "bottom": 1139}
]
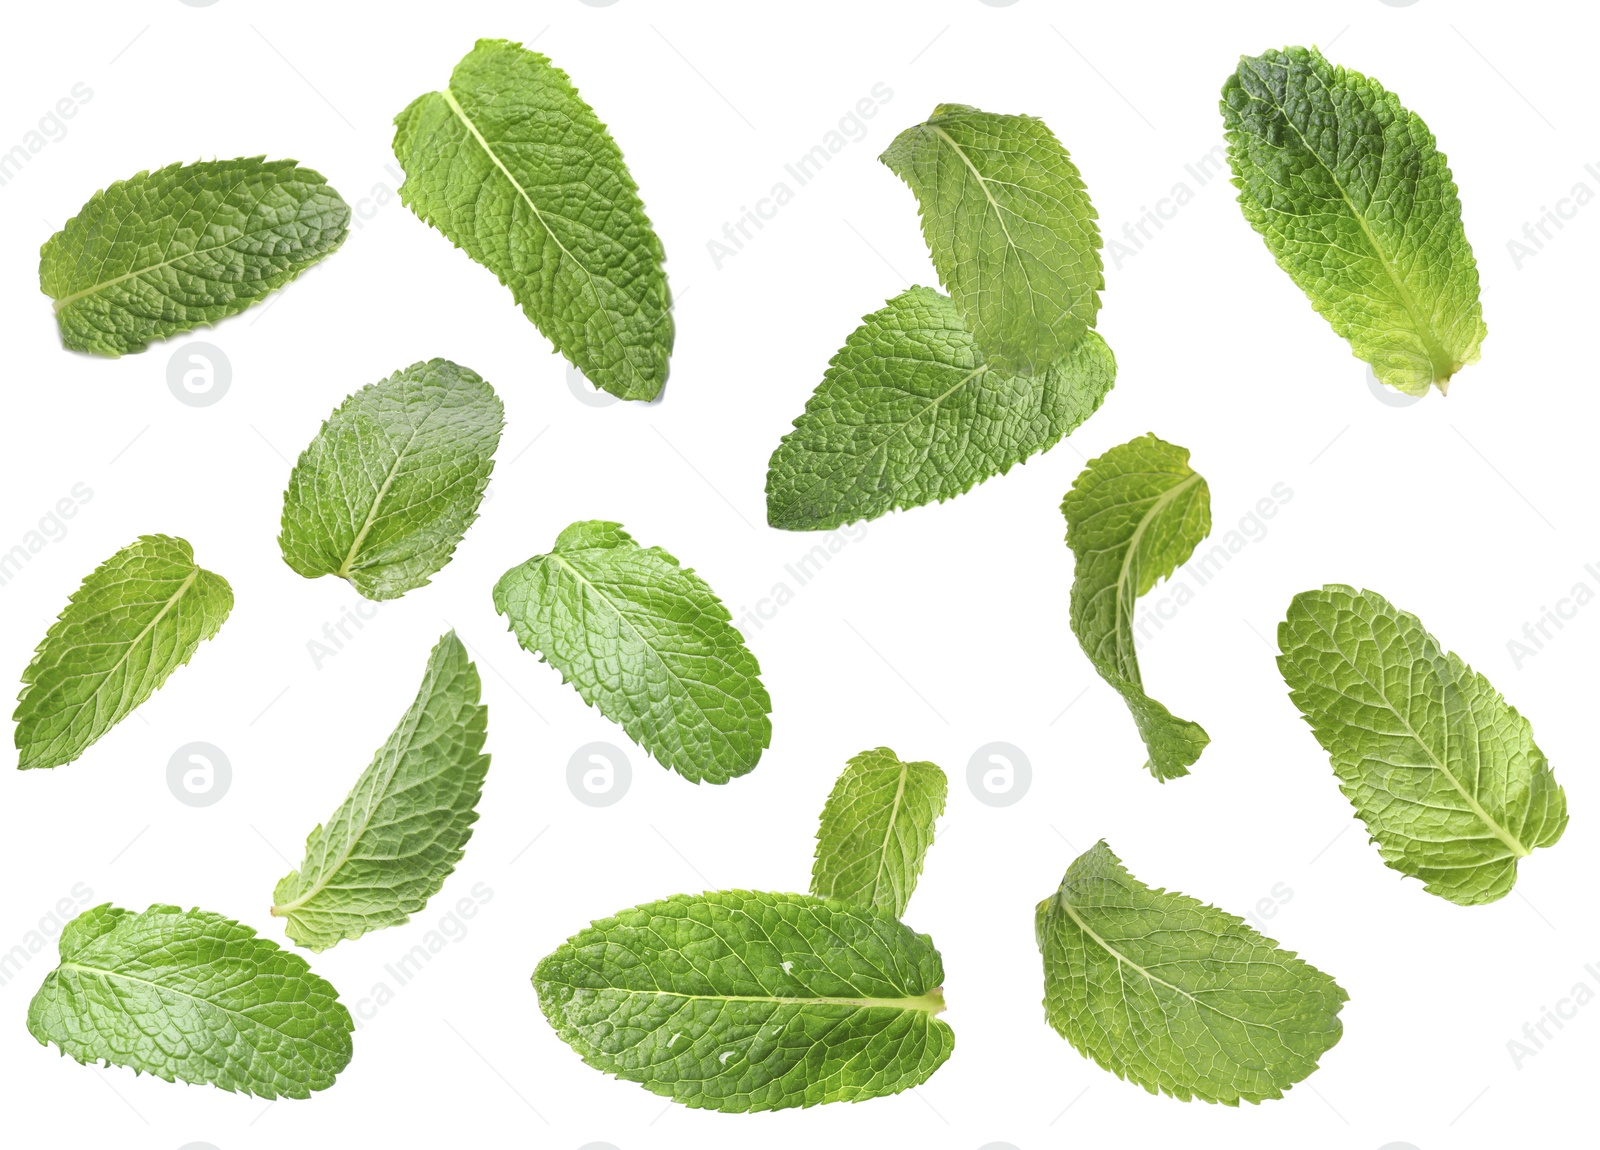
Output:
[{"left": 38, "top": 155, "right": 350, "bottom": 355}]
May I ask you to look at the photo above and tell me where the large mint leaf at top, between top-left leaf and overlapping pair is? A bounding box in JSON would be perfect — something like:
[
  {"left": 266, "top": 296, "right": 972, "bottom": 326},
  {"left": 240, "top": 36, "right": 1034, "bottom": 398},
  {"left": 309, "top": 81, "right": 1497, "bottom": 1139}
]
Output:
[{"left": 403, "top": 40, "right": 672, "bottom": 400}]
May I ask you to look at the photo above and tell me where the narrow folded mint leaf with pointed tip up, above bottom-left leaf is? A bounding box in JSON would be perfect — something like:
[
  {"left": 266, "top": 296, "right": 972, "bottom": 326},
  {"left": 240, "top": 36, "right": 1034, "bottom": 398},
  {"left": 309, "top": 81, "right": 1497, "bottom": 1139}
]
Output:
[{"left": 272, "top": 632, "right": 490, "bottom": 950}]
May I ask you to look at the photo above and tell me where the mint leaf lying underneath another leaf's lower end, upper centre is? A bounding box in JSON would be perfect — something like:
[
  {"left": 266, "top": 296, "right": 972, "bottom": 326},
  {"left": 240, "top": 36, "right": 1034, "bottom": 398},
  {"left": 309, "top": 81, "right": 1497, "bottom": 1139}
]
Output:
[{"left": 766, "top": 288, "right": 1117, "bottom": 531}]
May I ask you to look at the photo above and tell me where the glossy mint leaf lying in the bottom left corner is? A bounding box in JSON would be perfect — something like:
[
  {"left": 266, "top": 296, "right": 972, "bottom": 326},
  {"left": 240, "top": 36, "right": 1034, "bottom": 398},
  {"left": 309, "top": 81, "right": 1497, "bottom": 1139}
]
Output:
[{"left": 27, "top": 902, "right": 355, "bottom": 1099}]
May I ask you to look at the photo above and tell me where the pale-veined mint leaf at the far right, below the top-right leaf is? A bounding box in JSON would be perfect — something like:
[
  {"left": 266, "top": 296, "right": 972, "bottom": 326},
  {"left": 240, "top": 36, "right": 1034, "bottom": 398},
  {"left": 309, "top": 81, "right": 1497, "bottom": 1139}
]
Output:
[{"left": 1278, "top": 584, "right": 1566, "bottom": 907}]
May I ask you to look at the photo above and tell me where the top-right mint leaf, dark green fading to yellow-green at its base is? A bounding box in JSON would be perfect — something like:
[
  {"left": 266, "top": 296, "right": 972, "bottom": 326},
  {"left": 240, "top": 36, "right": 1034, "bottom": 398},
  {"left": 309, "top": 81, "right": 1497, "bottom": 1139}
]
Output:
[{"left": 1222, "top": 48, "right": 1488, "bottom": 395}]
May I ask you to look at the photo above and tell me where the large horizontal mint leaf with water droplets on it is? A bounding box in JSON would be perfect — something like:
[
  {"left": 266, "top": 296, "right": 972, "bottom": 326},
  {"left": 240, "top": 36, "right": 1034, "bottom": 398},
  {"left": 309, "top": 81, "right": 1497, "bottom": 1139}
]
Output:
[{"left": 533, "top": 891, "right": 955, "bottom": 1113}]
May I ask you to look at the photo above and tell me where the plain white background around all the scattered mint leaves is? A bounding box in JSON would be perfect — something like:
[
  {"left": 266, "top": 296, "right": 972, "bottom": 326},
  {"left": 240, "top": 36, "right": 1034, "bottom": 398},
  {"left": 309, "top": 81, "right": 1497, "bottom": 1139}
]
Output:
[{"left": 0, "top": 0, "right": 1600, "bottom": 1150}]
